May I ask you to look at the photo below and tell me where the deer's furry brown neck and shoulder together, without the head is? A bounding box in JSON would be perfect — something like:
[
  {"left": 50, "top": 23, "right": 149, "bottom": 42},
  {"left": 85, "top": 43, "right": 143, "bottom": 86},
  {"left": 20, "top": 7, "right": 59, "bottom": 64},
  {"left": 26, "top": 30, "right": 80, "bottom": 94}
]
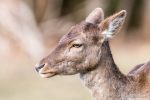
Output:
[{"left": 81, "top": 41, "right": 150, "bottom": 100}]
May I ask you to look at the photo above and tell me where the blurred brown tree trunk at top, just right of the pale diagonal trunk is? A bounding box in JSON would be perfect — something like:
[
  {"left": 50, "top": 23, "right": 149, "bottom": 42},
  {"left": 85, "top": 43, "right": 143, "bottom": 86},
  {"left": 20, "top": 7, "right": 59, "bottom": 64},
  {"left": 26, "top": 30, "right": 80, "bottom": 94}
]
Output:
[{"left": 34, "top": 0, "right": 62, "bottom": 24}]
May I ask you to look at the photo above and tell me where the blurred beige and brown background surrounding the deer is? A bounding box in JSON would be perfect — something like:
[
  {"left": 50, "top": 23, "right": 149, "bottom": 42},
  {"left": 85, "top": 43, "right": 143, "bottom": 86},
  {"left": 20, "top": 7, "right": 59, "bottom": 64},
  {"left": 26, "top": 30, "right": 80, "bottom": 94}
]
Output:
[{"left": 0, "top": 0, "right": 150, "bottom": 100}]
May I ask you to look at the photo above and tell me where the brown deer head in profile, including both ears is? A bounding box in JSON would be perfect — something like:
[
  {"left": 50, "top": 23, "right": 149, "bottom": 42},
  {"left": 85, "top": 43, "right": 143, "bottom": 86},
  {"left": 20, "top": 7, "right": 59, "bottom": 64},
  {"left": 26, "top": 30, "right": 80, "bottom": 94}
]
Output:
[{"left": 36, "top": 8, "right": 126, "bottom": 77}]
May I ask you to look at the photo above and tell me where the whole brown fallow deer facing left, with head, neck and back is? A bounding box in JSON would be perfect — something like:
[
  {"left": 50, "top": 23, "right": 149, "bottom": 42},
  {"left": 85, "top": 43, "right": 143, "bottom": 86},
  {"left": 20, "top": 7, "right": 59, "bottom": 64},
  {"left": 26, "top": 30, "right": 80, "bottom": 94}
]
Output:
[{"left": 36, "top": 8, "right": 150, "bottom": 100}]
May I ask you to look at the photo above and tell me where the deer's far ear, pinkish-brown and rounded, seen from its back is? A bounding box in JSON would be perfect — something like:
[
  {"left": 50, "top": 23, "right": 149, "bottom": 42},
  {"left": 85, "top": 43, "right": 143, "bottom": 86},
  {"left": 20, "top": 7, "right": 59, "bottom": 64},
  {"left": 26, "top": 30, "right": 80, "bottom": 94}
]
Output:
[{"left": 85, "top": 8, "right": 104, "bottom": 24}]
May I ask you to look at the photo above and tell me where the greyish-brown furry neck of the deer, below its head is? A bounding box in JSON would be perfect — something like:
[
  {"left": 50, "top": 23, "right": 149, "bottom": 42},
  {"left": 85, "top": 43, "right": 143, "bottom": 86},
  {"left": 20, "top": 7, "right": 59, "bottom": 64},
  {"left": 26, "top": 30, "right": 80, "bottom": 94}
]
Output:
[{"left": 80, "top": 41, "right": 126, "bottom": 100}]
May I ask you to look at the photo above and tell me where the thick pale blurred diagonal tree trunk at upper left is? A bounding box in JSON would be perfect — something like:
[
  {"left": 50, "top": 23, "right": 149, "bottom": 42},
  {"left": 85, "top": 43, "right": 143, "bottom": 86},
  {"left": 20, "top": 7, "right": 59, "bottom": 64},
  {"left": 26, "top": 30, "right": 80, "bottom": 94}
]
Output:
[{"left": 0, "top": 0, "right": 45, "bottom": 60}]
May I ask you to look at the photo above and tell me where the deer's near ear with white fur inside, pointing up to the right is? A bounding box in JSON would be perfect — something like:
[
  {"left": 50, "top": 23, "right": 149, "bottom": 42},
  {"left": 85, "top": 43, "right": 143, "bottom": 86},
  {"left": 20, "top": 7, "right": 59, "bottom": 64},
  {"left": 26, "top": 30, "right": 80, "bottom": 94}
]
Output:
[{"left": 100, "top": 10, "right": 126, "bottom": 38}]
